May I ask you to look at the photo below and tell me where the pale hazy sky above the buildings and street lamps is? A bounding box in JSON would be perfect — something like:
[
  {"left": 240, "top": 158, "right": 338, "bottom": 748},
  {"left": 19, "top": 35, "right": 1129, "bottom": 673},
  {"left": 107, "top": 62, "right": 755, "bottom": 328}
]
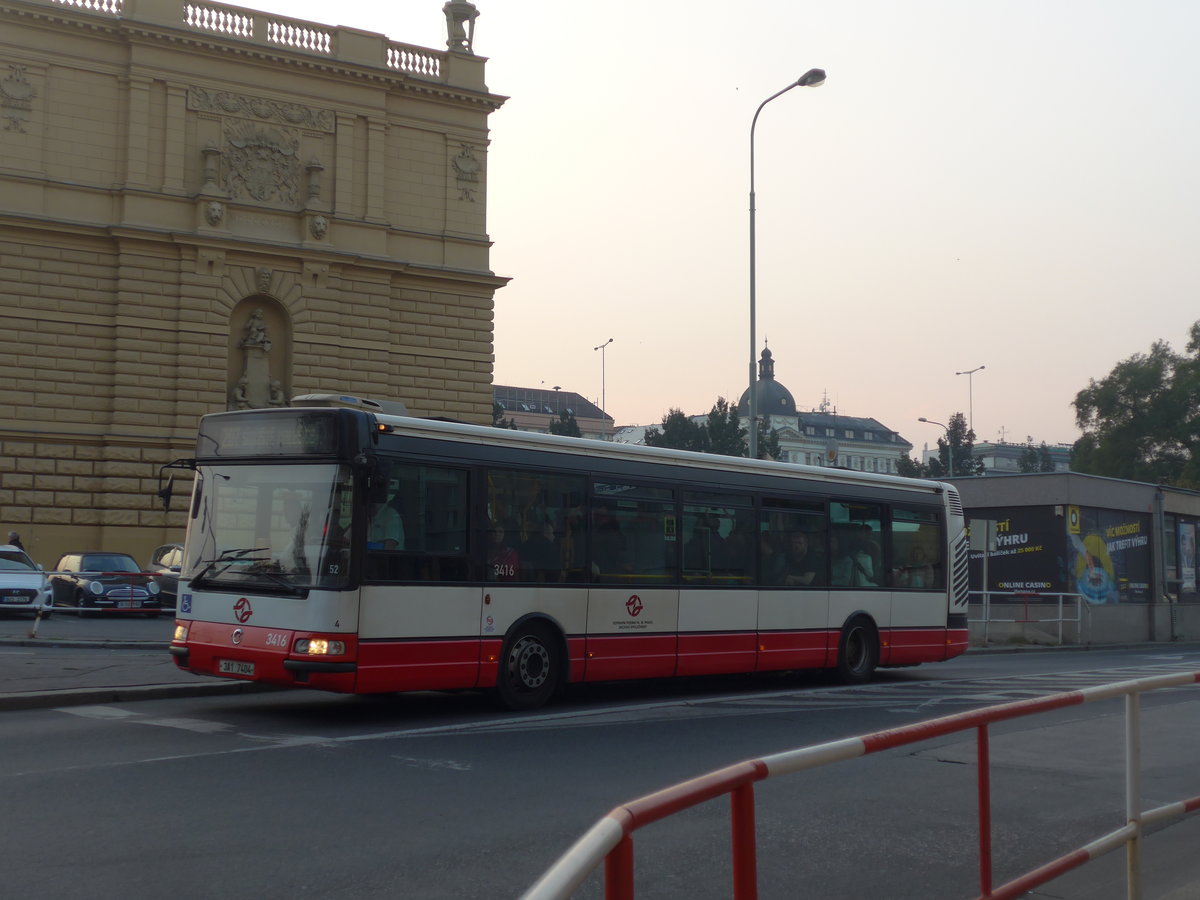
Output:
[{"left": 248, "top": 0, "right": 1200, "bottom": 450}]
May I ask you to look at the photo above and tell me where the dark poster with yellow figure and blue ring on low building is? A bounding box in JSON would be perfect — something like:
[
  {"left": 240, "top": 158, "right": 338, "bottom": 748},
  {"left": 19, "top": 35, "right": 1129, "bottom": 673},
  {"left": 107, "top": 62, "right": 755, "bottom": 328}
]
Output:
[{"left": 1067, "top": 506, "right": 1152, "bottom": 604}]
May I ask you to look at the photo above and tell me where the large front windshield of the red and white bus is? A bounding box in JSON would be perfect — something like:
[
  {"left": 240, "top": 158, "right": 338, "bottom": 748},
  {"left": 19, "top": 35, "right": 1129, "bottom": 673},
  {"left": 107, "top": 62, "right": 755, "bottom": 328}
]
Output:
[{"left": 181, "top": 463, "right": 353, "bottom": 595}]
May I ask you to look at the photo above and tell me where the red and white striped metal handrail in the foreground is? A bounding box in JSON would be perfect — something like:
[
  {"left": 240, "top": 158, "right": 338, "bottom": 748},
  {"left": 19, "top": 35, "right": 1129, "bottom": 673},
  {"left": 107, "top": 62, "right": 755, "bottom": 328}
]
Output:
[{"left": 522, "top": 672, "right": 1200, "bottom": 900}]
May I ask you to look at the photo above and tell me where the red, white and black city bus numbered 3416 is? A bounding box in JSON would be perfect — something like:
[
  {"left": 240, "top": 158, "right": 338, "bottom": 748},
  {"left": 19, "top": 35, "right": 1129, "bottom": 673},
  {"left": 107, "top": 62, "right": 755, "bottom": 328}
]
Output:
[{"left": 170, "top": 395, "right": 968, "bottom": 709}]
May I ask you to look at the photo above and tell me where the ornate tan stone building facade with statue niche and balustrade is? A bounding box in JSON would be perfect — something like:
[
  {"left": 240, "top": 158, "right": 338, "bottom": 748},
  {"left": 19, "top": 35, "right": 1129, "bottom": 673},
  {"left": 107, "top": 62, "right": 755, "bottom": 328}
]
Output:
[{"left": 0, "top": 0, "right": 505, "bottom": 566}]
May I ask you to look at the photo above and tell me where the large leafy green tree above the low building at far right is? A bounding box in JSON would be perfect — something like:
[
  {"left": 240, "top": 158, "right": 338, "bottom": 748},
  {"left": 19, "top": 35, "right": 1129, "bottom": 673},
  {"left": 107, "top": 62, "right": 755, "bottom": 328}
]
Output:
[{"left": 1070, "top": 322, "right": 1200, "bottom": 488}]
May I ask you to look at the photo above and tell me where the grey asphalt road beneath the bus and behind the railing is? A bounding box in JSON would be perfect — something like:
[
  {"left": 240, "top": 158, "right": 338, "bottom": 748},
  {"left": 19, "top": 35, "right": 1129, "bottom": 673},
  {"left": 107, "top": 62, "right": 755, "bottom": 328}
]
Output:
[{"left": 0, "top": 633, "right": 1200, "bottom": 900}]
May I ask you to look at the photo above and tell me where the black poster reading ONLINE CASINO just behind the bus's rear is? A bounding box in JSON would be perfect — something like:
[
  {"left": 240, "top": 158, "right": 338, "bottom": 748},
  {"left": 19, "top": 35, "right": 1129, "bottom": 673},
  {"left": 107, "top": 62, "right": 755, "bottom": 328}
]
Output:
[{"left": 968, "top": 506, "right": 1075, "bottom": 602}]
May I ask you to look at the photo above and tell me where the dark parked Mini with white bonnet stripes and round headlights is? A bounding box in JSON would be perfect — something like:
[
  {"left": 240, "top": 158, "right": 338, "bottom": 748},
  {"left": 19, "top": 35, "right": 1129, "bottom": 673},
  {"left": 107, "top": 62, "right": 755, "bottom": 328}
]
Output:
[{"left": 50, "top": 551, "right": 162, "bottom": 616}]
